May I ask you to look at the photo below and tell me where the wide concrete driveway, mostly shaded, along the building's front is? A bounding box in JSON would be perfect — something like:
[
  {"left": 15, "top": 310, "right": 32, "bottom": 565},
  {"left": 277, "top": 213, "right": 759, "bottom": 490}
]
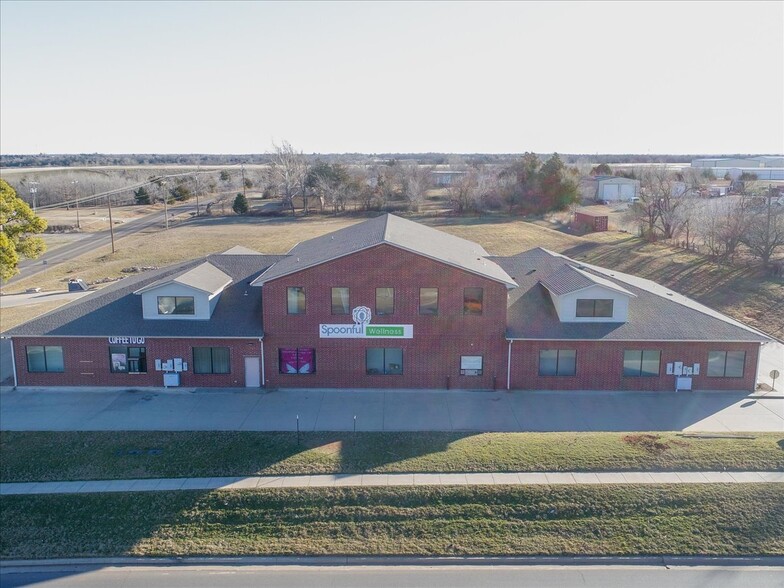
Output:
[{"left": 0, "top": 386, "right": 784, "bottom": 432}]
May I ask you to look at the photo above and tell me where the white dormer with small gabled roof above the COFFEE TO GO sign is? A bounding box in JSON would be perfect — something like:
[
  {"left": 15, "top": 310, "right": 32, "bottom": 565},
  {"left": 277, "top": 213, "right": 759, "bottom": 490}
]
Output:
[{"left": 134, "top": 262, "right": 232, "bottom": 320}]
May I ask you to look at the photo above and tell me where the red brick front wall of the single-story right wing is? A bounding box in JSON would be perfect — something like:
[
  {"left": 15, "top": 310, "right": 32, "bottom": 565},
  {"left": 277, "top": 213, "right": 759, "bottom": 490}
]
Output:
[{"left": 504, "top": 341, "right": 759, "bottom": 391}]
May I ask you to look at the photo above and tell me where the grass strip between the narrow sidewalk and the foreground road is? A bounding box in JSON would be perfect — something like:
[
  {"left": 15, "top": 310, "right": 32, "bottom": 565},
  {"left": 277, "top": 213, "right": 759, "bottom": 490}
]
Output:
[{"left": 0, "top": 484, "right": 784, "bottom": 558}]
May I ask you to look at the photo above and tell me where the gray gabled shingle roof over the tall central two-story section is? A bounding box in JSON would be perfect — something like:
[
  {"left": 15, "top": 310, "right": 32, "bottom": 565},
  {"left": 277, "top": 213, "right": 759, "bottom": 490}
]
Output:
[{"left": 253, "top": 214, "right": 516, "bottom": 287}]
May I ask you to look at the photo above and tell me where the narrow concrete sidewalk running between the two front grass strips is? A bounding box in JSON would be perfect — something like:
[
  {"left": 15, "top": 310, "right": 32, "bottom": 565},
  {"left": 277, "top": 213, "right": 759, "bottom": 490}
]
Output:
[{"left": 0, "top": 471, "right": 784, "bottom": 495}]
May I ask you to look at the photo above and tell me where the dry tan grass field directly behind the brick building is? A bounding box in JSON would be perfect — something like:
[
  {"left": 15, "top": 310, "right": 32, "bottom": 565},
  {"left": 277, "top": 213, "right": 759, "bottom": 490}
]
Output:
[{"left": 2, "top": 210, "right": 784, "bottom": 338}]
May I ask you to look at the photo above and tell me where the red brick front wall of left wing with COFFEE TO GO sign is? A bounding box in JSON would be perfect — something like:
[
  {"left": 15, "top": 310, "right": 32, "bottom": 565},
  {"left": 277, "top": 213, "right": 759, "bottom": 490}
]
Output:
[{"left": 13, "top": 333, "right": 261, "bottom": 388}]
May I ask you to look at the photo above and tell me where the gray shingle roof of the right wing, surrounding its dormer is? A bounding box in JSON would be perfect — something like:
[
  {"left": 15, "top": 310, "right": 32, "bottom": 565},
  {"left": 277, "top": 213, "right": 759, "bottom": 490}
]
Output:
[{"left": 492, "top": 248, "right": 768, "bottom": 341}]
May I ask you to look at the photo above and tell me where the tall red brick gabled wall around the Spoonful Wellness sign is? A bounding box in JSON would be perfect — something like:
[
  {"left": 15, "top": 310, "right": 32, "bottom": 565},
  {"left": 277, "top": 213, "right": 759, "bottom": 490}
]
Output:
[{"left": 264, "top": 245, "right": 506, "bottom": 388}]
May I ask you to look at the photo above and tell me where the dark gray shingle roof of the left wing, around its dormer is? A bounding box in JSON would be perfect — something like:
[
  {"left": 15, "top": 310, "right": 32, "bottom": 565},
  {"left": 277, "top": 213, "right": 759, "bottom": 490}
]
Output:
[{"left": 6, "top": 255, "right": 281, "bottom": 337}]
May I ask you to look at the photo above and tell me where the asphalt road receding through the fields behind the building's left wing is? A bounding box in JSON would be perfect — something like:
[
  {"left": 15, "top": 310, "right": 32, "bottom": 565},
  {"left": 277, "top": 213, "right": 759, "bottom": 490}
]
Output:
[{"left": 6, "top": 201, "right": 208, "bottom": 284}]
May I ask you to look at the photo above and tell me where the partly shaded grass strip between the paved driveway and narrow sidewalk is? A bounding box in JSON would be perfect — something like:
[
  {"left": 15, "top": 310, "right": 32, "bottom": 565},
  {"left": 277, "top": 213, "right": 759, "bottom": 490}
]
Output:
[{"left": 0, "top": 431, "right": 784, "bottom": 482}]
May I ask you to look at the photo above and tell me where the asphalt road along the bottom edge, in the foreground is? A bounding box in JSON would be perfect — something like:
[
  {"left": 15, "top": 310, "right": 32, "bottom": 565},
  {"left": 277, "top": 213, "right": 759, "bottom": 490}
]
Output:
[{"left": 0, "top": 565, "right": 784, "bottom": 588}]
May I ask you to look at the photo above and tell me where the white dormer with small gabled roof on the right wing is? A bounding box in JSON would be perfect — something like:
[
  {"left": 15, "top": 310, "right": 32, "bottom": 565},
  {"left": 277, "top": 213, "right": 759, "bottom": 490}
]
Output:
[{"left": 539, "top": 265, "right": 636, "bottom": 323}]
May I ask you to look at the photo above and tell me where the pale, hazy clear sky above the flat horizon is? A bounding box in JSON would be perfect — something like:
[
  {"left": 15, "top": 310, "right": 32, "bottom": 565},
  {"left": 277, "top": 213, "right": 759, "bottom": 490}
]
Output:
[{"left": 0, "top": 0, "right": 784, "bottom": 154}]
